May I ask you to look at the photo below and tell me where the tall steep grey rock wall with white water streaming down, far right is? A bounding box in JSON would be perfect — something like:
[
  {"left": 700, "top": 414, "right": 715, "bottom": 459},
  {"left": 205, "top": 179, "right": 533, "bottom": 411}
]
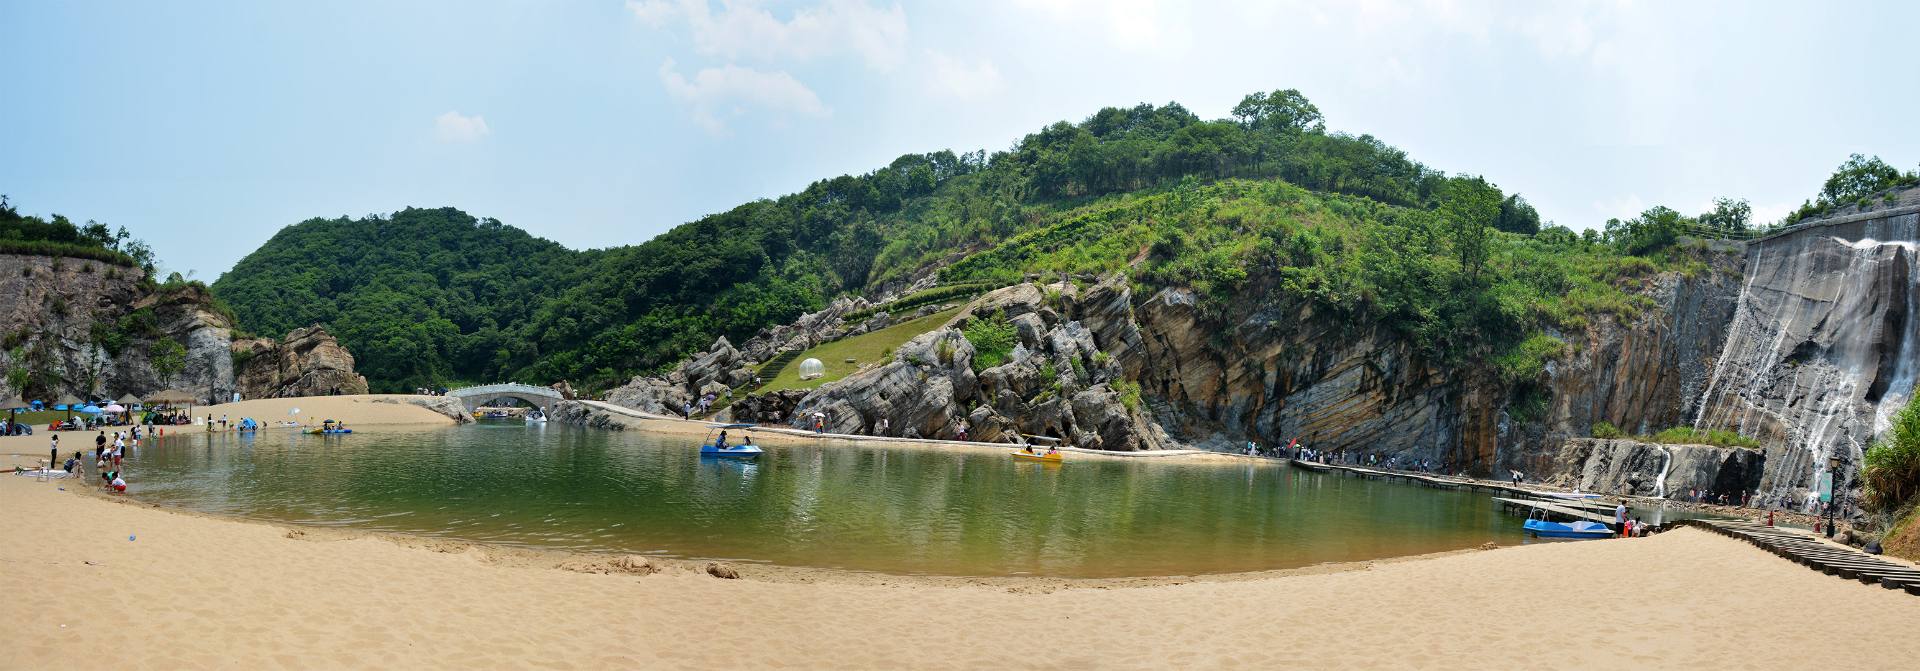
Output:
[{"left": 1693, "top": 208, "right": 1920, "bottom": 496}]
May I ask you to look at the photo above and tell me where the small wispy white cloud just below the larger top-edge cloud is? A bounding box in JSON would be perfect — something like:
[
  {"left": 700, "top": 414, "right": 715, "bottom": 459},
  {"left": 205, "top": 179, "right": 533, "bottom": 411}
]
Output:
[{"left": 660, "top": 60, "right": 831, "bottom": 135}]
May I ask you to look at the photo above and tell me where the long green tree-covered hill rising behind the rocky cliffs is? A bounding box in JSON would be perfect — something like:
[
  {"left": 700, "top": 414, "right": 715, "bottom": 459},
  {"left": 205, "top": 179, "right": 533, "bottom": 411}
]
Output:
[{"left": 213, "top": 90, "right": 1820, "bottom": 388}]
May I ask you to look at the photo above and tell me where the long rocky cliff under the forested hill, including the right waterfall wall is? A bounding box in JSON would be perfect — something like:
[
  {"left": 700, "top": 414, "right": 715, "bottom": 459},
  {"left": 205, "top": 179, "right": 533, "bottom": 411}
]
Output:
[{"left": 587, "top": 192, "right": 1920, "bottom": 500}]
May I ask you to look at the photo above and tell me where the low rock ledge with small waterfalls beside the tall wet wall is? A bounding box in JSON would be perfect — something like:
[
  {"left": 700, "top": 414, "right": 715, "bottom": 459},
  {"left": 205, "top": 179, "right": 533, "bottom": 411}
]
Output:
[{"left": 1521, "top": 438, "right": 1766, "bottom": 498}]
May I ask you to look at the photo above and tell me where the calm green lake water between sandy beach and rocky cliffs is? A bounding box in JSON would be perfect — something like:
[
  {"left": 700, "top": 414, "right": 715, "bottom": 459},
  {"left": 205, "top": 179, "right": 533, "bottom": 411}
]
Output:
[{"left": 127, "top": 423, "right": 1521, "bottom": 577}]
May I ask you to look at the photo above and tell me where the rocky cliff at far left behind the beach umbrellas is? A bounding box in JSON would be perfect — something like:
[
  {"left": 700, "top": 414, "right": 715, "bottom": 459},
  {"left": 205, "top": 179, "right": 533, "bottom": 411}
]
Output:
[{"left": 0, "top": 254, "right": 365, "bottom": 400}]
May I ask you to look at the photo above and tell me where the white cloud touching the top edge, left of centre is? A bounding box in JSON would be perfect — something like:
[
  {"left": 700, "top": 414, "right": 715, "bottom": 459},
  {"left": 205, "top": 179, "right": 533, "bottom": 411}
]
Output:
[{"left": 626, "top": 0, "right": 906, "bottom": 71}]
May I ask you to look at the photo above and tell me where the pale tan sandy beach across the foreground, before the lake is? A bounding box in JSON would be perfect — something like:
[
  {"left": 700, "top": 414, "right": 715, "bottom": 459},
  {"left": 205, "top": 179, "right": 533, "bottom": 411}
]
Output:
[{"left": 0, "top": 451, "right": 1920, "bottom": 669}]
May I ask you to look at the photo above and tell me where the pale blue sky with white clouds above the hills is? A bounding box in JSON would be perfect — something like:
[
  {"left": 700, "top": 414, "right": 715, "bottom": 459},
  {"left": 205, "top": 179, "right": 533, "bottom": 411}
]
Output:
[{"left": 0, "top": 0, "right": 1920, "bottom": 281}]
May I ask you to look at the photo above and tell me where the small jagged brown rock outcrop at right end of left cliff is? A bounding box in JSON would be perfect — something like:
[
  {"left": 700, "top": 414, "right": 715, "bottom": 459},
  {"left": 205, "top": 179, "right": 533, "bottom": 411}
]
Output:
[{"left": 232, "top": 325, "right": 367, "bottom": 398}]
